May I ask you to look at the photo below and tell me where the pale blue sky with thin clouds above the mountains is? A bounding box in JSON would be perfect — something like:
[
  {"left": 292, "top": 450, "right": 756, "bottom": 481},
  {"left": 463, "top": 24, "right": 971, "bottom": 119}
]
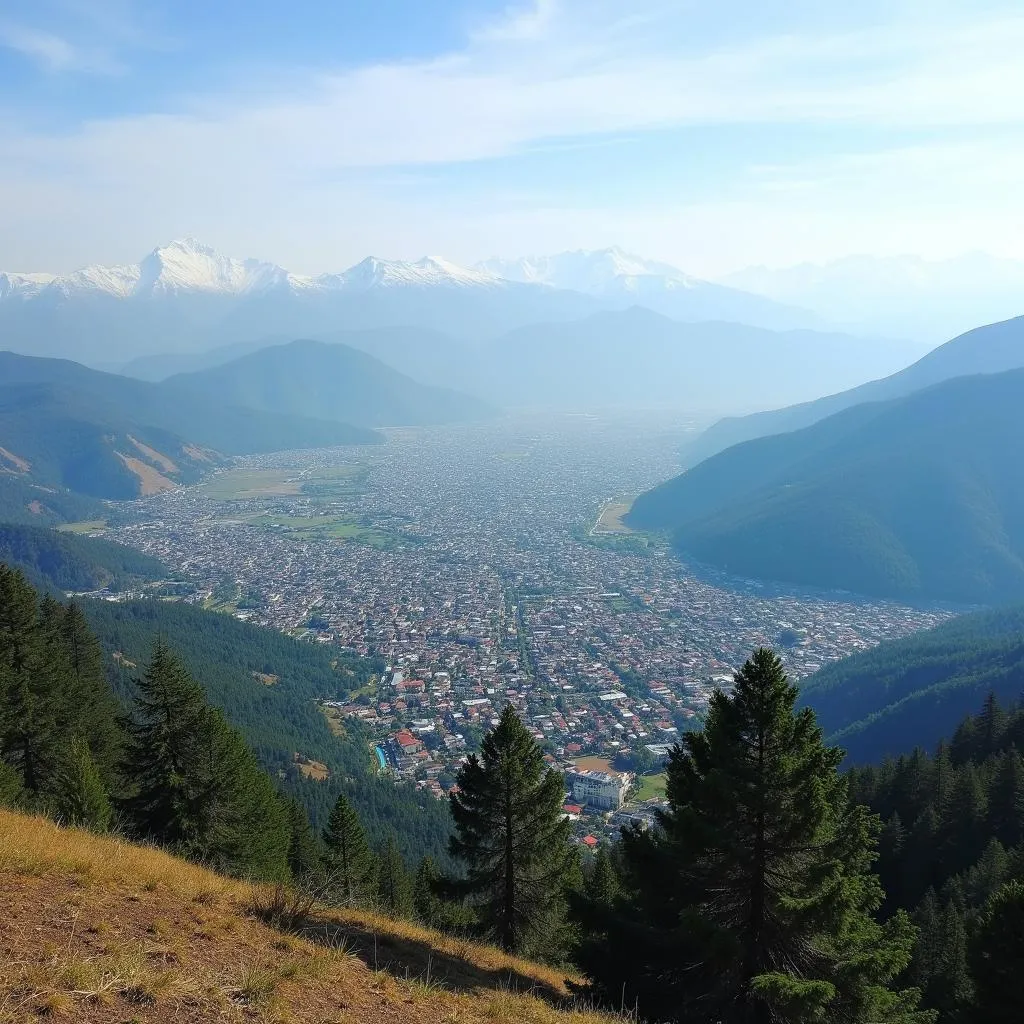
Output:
[{"left": 0, "top": 0, "right": 1024, "bottom": 278}]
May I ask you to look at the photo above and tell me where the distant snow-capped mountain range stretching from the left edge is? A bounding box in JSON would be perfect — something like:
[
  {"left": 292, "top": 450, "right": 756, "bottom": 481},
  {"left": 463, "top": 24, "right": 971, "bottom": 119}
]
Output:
[{"left": 0, "top": 239, "right": 827, "bottom": 369}]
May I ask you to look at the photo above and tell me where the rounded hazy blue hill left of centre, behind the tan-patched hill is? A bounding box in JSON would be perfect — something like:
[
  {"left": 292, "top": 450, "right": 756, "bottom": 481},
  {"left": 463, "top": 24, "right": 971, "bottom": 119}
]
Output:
[{"left": 161, "top": 341, "right": 492, "bottom": 427}]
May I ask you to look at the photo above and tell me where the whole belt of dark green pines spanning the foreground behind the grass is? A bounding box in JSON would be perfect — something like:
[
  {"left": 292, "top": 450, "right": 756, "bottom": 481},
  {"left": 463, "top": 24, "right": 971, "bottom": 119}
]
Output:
[{"left": 0, "top": 552, "right": 1024, "bottom": 1024}]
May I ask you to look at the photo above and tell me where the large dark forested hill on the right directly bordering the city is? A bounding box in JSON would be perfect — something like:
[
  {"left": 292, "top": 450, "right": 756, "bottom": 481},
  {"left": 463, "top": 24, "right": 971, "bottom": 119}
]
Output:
[{"left": 629, "top": 370, "right": 1024, "bottom": 603}]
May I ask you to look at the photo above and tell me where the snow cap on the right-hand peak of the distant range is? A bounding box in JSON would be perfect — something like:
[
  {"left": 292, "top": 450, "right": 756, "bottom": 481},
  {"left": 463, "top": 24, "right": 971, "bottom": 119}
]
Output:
[{"left": 475, "top": 247, "right": 702, "bottom": 295}]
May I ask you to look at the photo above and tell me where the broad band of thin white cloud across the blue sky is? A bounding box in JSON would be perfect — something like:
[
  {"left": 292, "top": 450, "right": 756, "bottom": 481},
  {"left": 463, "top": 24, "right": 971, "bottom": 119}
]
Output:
[{"left": 0, "top": 0, "right": 1024, "bottom": 271}]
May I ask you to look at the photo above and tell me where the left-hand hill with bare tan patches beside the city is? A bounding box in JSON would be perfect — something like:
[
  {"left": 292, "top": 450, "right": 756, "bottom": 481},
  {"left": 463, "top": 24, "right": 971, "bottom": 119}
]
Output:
[{"left": 0, "top": 352, "right": 380, "bottom": 512}]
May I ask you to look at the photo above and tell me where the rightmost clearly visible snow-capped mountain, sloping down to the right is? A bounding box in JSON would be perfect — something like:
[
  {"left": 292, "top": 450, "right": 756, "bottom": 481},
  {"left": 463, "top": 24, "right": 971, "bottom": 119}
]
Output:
[{"left": 475, "top": 247, "right": 820, "bottom": 330}]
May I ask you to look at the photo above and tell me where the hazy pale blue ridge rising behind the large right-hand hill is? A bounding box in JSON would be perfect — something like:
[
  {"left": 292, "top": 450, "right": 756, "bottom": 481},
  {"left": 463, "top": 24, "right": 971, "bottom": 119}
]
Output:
[{"left": 684, "top": 307, "right": 1024, "bottom": 465}]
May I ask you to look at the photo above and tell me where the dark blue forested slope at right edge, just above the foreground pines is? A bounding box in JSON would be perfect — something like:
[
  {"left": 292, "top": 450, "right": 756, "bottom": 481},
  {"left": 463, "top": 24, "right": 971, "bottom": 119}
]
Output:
[{"left": 800, "top": 605, "right": 1024, "bottom": 763}]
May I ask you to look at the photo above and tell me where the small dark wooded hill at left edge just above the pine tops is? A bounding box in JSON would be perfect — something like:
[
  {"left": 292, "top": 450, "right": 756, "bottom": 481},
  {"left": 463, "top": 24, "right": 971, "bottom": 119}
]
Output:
[{"left": 0, "top": 523, "right": 167, "bottom": 591}]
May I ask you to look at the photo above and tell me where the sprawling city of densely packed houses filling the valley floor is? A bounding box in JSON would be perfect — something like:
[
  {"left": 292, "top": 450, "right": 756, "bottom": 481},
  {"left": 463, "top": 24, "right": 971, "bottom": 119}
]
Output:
[{"left": 92, "top": 414, "right": 948, "bottom": 842}]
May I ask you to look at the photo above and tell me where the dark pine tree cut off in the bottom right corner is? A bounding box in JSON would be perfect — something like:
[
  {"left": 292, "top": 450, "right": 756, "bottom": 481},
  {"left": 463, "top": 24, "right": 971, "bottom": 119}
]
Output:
[{"left": 970, "top": 882, "right": 1024, "bottom": 1024}]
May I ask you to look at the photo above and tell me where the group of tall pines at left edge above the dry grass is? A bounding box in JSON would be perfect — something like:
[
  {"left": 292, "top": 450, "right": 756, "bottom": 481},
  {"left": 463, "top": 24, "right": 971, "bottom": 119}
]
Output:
[{"left": 0, "top": 564, "right": 289, "bottom": 879}]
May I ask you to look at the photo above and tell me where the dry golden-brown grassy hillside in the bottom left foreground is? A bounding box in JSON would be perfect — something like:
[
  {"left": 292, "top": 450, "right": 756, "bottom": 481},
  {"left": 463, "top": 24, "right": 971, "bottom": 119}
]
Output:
[{"left": 0, "top": 810, "right": 609, "bottom": 1024}]
